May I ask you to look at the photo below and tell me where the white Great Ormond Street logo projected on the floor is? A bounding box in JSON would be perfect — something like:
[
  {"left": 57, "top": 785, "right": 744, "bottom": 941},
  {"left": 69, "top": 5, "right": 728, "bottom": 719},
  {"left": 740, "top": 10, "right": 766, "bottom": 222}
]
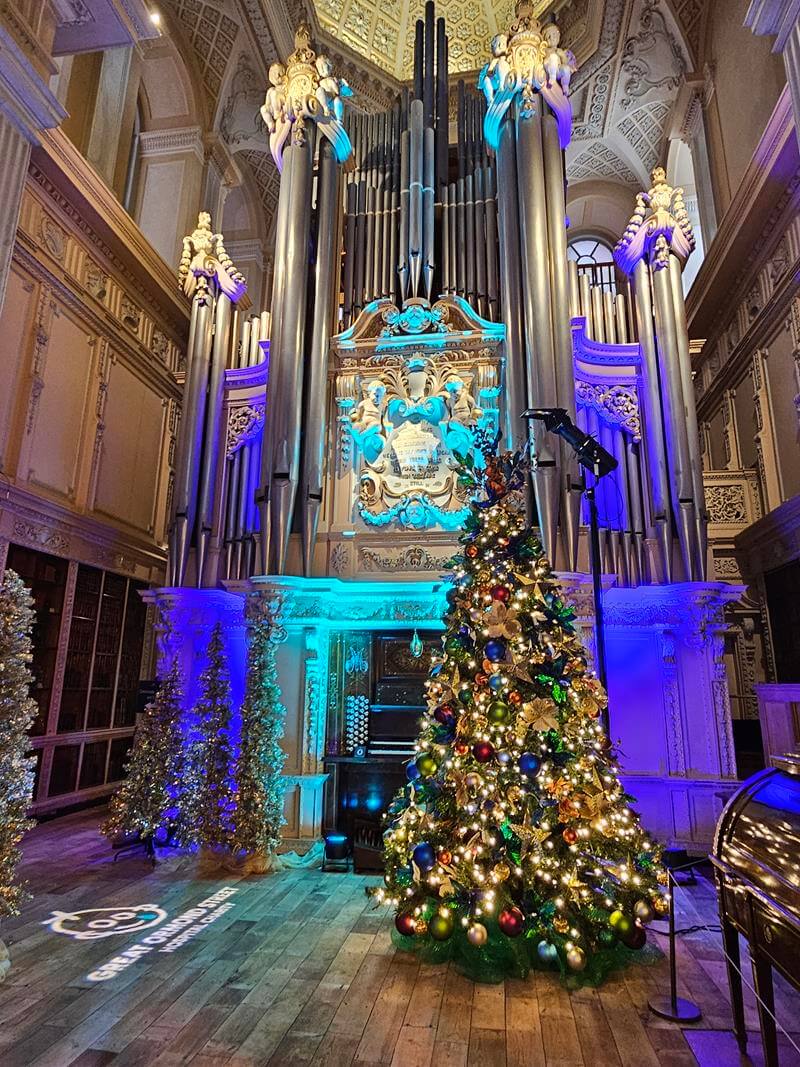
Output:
[{"left": 43, "top": 886, "right": 239, "bottom": 982}]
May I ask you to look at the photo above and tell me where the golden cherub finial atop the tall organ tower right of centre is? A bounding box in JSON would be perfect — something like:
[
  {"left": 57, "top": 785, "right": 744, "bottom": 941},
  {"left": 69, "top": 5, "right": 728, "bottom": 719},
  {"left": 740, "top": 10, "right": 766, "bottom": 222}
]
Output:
[{"left": 478, "top": 0, "right": 577, "bottom": 149}]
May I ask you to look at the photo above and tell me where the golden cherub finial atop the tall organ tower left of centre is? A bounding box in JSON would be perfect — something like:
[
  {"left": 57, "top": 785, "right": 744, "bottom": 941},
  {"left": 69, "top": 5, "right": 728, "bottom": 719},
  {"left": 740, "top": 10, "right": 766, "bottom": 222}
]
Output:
[{"left": 260, "top": 22, "right": 353, "bottom": 171}]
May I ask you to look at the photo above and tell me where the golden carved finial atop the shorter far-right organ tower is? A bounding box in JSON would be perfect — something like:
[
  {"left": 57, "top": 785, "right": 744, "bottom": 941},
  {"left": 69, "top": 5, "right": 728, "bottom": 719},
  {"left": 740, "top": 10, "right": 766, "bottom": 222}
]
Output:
[{"left": 614, "top": 166, "right": 694, "bottom": 274}]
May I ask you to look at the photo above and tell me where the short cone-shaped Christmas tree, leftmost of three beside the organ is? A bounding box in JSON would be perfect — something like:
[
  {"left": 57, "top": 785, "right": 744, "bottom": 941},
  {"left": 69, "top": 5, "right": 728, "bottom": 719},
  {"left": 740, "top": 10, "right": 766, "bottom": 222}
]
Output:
[{"left": 100, "top": 657, "right": 187, "bottom": 843}]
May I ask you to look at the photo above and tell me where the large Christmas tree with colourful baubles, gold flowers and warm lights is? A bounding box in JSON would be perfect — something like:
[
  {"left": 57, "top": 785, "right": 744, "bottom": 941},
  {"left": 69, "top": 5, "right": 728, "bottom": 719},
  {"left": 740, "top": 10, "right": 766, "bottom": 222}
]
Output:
[{"left": 371, "top": 447, "right": 666, "bottom": 983}]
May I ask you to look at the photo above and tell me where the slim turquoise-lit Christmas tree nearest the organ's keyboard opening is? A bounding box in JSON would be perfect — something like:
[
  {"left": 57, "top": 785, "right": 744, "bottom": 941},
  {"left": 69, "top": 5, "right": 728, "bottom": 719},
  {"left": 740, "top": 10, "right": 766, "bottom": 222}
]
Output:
[{"left": 233, "top": 603, "right": 286, "bottom": 870}]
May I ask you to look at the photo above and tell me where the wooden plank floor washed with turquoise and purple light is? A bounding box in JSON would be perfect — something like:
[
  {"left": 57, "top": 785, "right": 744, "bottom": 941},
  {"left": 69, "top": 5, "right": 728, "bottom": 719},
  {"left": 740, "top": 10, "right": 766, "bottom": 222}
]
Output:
[{"left": 0, "top": 812, "right": 800, "bottom": 1067}]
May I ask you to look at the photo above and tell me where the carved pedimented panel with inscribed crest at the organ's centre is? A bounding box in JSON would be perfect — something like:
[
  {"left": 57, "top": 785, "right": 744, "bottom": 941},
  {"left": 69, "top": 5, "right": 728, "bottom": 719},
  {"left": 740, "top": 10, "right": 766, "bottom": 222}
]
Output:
[{"left": 325, "top": 297, "right": 503, "bottom": 578}]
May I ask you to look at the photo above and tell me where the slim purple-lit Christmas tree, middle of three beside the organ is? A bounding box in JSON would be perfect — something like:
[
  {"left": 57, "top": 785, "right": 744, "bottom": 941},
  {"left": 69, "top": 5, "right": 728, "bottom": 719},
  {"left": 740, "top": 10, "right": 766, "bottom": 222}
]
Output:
[{"left": 188, "top": 622, "right": 237, "bottom": 850}]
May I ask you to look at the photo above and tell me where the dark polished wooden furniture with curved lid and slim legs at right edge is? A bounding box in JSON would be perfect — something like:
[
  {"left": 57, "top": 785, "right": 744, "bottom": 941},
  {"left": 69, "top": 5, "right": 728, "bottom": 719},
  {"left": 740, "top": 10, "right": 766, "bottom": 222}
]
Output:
[{"left": 711, "top": 754, "right": 800, "bottom": 1067}]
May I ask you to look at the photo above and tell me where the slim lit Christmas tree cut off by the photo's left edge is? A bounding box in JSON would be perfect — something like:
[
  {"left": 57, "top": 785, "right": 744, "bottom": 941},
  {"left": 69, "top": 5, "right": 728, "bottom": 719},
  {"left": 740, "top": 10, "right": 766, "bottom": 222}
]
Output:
[{"left": 0, "top": 571, "right": 36, "bottom": 926}]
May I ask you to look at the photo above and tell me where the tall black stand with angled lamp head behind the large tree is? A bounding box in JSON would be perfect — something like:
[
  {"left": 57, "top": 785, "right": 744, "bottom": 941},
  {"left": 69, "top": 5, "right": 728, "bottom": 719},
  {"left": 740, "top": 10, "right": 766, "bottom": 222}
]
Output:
[{"left": 522, "top": 408, "right": 619, "bottom": 737}]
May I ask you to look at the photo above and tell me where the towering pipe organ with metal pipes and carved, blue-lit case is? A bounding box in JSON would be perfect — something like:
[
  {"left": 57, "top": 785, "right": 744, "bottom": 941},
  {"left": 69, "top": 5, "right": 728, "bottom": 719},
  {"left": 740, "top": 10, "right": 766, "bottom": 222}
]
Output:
[{"left": 161, "top": 0, "right": 737, "bottom": 843}]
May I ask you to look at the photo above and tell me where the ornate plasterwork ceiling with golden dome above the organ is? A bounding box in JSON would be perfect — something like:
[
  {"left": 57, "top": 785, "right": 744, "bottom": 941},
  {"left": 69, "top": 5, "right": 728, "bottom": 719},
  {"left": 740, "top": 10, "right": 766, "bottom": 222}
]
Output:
[{"left": 163, "top": 0, "right": 708, "bottom": 244}]
